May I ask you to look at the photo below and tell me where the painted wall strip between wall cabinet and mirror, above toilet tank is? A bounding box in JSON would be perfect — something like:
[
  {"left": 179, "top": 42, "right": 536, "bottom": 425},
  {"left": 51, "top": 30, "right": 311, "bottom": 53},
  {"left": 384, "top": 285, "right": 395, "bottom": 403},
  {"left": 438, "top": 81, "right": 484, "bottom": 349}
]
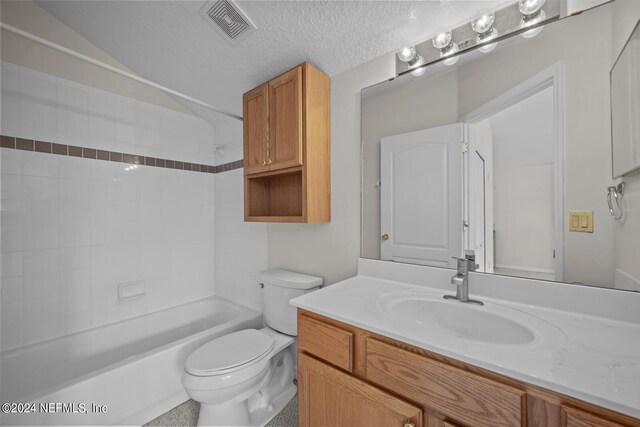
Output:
[{"left": 267, "top": 54, "right": 395, "bottom": 284}]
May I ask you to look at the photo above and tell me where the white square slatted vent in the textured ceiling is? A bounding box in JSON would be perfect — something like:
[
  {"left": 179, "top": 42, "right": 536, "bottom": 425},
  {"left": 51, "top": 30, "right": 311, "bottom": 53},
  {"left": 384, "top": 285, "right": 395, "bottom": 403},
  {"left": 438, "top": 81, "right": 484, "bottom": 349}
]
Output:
[{"left": 202, "top": 0, "right": 256, "bottom": 44}]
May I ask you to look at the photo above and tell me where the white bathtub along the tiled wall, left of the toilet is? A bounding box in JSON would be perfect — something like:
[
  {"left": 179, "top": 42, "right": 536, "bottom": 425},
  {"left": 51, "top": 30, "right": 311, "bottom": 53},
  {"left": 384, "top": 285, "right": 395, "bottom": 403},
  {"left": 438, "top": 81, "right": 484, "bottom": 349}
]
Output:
[{"left": 0, "top": 297, "right": 262, "bottom": 425}]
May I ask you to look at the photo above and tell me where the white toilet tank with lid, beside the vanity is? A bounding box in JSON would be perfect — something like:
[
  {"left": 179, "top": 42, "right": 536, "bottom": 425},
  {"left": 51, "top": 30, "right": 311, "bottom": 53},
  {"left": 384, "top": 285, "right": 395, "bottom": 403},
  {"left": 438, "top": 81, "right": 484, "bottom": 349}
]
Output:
[{"left": 260, "top": 269, "right": 322, "bottom": 336}]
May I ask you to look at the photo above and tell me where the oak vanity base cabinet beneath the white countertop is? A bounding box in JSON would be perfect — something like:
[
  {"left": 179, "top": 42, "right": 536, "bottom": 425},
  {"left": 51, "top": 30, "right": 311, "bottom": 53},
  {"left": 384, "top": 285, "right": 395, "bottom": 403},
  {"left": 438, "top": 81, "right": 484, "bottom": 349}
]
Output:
[{"left": 298, "top": 310, "right": 640, "bottom": 427}]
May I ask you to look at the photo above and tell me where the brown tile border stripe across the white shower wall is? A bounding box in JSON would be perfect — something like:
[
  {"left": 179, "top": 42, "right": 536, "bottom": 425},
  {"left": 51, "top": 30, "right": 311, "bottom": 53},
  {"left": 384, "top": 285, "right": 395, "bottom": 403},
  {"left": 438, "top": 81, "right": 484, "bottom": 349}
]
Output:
[{"left": 0, "top": 135, "right": 243, "bottom": 173}]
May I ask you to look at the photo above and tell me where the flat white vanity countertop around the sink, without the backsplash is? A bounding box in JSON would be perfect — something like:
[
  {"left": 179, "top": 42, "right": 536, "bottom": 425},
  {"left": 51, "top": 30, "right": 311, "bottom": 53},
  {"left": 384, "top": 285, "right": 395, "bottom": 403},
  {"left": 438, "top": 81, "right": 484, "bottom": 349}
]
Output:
[{"left": 291, "top": 273, "right": 640, "bottom": 418}]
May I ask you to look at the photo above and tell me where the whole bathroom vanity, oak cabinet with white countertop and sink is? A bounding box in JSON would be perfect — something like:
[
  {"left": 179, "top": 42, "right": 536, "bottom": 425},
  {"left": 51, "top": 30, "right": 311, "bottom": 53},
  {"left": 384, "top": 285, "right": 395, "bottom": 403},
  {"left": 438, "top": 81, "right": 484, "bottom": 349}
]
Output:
[{"left": 292, "top": 260, "right": 640, "bottom": 427}]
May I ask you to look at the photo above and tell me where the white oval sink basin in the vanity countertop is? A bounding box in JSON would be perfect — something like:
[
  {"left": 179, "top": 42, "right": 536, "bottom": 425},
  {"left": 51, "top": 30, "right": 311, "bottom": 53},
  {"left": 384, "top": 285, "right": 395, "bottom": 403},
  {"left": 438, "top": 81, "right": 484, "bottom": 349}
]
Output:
[{"left": 378, "top": 291, "right": 559, "bottom": 345}]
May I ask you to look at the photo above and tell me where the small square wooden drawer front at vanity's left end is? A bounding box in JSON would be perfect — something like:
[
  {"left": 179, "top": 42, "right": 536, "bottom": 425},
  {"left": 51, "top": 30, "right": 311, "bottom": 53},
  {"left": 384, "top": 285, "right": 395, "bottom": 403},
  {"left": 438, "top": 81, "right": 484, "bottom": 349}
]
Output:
[{"left": 298, "top": 315, "right": 354, "bottom": 372}]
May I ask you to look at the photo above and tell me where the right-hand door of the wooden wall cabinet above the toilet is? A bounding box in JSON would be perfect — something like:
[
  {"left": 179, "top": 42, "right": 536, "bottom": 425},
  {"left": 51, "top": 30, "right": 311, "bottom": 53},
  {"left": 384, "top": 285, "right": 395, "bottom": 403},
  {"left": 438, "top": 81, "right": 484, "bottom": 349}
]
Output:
[{"left": 267, "top": 67, "right": 303, "bottom": 170}]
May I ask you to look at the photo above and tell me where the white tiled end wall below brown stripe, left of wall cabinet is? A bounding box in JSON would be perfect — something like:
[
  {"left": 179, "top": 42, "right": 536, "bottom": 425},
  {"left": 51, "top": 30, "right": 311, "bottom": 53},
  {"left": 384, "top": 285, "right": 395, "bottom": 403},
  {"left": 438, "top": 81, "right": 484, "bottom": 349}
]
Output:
[{"left": 214, "top": 169, "right": 266, "bottom": 311}]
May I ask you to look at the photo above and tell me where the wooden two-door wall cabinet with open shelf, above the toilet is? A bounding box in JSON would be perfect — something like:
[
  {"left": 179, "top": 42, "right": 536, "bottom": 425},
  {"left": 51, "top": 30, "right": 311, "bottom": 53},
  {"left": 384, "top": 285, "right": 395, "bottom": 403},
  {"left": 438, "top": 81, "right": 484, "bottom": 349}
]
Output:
[{"left": 243, "top": 62, "right": 331, "bottom": 222}]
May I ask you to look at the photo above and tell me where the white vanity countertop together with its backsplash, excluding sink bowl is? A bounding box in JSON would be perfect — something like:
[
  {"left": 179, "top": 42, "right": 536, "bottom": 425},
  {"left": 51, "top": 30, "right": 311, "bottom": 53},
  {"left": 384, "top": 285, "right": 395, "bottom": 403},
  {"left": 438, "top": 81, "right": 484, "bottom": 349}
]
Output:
[{"left": 292, "top": 259, "right": 640, "bottom": 417}]
